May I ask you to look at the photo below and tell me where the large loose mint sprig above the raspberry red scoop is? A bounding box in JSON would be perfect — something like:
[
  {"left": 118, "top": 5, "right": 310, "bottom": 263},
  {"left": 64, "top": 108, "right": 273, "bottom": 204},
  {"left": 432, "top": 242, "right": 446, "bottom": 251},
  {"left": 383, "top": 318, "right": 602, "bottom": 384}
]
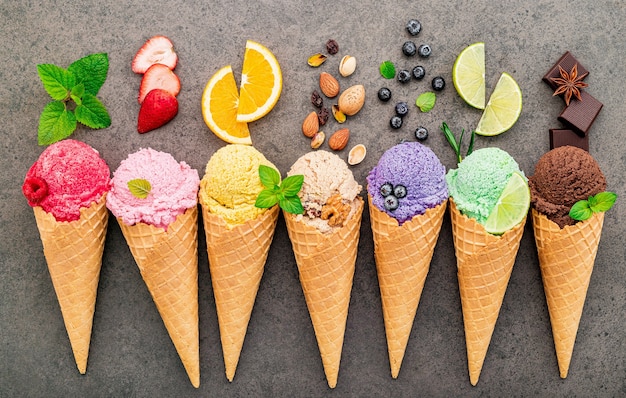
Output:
[{"left": 37, "top": 53, "right": 111, "bottom": 145}]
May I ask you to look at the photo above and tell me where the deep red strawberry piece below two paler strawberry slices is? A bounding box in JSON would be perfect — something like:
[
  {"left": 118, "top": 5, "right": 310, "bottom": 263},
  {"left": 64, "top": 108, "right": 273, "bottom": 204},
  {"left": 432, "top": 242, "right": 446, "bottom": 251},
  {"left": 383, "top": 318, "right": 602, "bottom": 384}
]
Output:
[{"left": 137, "top": 88, "right": 178, "bottom": 133}]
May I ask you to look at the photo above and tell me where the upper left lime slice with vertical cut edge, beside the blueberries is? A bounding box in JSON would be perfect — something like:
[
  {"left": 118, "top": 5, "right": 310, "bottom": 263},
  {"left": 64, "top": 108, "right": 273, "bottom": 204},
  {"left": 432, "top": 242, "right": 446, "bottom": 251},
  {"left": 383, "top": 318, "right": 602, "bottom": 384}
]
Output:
[{"left": 452, "top": 42, "right": 485, "bottom": 109}]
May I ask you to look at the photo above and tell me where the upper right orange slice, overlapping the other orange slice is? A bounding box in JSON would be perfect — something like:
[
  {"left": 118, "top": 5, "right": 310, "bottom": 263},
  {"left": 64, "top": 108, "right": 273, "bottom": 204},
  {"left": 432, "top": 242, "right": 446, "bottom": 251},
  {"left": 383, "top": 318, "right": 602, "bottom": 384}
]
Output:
[{"left": 237, "top": 40, "right": 283, "bottom": 123}]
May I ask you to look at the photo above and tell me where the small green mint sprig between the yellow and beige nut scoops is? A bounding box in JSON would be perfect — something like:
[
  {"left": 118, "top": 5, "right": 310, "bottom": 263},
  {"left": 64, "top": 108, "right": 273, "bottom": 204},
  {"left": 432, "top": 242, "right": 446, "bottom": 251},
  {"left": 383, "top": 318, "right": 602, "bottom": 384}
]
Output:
[{"left": 254, "top": 165, "right": 304, "bottom": 214}]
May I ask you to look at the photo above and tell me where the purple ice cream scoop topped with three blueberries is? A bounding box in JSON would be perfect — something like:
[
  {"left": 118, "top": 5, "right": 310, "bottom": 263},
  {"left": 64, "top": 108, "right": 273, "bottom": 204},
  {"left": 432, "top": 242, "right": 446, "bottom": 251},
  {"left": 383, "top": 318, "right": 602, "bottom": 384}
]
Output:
[{"left": 367, "top": 142, "right": 448, "bottom": 225}]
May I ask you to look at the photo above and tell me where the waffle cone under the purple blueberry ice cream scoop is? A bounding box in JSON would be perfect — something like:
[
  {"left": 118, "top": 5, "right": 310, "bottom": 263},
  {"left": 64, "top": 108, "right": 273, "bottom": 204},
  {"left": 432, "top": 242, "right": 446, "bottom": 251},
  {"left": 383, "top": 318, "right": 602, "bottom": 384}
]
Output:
[{"left": 369, "top": 197, "right": 447, "bottom": 379}]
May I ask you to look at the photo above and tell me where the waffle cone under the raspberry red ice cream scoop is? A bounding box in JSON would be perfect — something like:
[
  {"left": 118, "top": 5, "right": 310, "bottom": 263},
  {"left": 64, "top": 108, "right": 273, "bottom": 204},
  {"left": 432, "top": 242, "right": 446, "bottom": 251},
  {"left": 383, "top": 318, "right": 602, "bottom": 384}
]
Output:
[{"left": 33, "top": 195, "right": 109, "bottom": 374}]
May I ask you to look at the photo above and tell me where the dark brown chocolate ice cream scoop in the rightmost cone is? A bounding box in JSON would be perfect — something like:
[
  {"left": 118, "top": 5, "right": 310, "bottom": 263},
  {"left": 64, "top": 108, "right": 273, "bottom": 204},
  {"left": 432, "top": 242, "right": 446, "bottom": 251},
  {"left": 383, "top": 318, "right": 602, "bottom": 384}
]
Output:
[{"left": 528, "top": 146, "right": 606, "bottom": 228}]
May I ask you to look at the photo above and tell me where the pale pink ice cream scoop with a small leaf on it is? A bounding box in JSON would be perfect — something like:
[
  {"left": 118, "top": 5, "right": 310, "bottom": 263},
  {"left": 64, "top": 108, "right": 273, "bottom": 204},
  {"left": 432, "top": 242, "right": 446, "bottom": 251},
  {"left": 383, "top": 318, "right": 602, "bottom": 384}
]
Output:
[{"left": 107, "top": 148, "right": 200, "bottom": 229}]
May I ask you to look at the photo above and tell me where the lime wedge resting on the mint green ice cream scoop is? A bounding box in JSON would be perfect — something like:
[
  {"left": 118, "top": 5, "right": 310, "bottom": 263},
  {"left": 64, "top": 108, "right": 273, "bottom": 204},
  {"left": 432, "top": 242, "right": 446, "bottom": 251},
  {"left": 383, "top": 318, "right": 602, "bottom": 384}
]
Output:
[{"left": 485, "top": 172, "right": 530, "bottom": 235}]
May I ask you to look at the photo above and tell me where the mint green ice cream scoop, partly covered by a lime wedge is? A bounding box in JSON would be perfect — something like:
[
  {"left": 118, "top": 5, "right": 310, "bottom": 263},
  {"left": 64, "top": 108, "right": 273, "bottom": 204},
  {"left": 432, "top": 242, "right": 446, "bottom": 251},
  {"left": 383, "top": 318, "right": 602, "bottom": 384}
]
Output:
[{"left": 446, "top": 148, "right": 524, "bottom": 225}]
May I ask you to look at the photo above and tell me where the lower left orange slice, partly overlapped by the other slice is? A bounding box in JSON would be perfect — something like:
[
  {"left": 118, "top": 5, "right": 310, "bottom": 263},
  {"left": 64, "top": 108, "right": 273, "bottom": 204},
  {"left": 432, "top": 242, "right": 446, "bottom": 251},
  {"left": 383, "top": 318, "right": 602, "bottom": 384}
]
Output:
[{"left": 202, "top": 65, "right": 252, "bottom": 145}]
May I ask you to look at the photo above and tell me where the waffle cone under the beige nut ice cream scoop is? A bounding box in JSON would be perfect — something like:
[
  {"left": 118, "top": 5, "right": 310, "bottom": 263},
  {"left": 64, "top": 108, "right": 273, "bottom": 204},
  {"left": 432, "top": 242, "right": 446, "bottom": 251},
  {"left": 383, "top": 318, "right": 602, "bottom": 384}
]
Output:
[{"left": 284, "top": 197, "right": 363, "bottom": 388}]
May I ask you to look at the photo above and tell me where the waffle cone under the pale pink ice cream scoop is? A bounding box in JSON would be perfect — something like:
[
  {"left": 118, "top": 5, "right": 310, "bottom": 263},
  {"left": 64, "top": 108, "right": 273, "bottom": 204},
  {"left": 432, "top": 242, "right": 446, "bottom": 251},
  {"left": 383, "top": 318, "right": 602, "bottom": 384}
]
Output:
[{"left": 117, "top": 207, "right": 200, "bottom": 388}]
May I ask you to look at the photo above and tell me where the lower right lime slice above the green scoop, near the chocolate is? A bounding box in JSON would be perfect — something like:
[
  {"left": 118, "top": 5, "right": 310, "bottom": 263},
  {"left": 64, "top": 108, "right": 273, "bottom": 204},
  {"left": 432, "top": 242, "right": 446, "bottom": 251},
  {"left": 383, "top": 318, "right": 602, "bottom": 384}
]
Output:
[{"left": 476, "top": 72, "right": 522, "bottom": 136}]
